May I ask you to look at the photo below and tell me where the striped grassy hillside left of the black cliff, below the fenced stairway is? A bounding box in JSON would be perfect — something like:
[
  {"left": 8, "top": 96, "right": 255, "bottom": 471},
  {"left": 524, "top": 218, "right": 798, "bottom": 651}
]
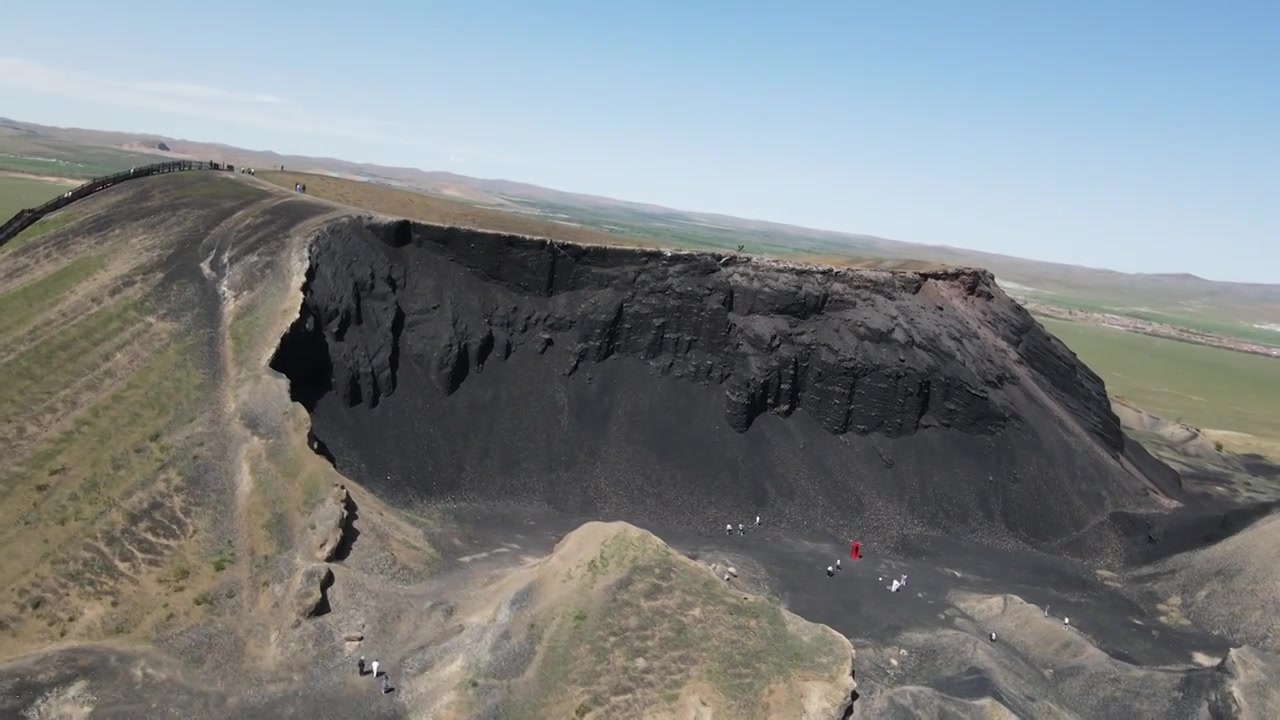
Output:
[{"left": 0, "top": 173, "right": 337, "bottom": 657}]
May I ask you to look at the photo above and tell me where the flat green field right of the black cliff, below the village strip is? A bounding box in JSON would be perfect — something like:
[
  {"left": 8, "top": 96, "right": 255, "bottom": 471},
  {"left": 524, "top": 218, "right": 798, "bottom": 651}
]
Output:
[{"left": 1039, "top": 318, "right": 1280, "bottom": 438}]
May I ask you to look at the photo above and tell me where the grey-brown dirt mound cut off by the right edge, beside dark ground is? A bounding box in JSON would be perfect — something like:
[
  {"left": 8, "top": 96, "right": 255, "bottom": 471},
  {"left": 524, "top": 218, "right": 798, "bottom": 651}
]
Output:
[{"left": 1133, "top": 515, "right": 1280, "bottom": 652}]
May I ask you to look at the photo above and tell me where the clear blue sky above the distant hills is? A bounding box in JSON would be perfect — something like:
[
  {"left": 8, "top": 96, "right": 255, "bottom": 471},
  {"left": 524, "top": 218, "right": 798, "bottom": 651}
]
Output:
[{"left": 0, "top": 0, "right": 1280, "bottom": 282}]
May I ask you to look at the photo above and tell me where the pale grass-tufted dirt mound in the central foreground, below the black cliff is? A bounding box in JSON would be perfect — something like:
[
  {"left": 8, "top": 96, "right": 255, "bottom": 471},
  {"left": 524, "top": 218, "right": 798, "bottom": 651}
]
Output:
[{"left": 403, "top": 523, "right": 854, "bottom": 719}]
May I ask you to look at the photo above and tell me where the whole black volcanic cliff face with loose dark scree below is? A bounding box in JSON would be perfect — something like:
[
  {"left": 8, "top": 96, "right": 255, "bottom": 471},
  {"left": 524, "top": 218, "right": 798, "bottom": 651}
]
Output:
[{"left": 273, "top": 218, "right": 1177, "bottom": 542}]
